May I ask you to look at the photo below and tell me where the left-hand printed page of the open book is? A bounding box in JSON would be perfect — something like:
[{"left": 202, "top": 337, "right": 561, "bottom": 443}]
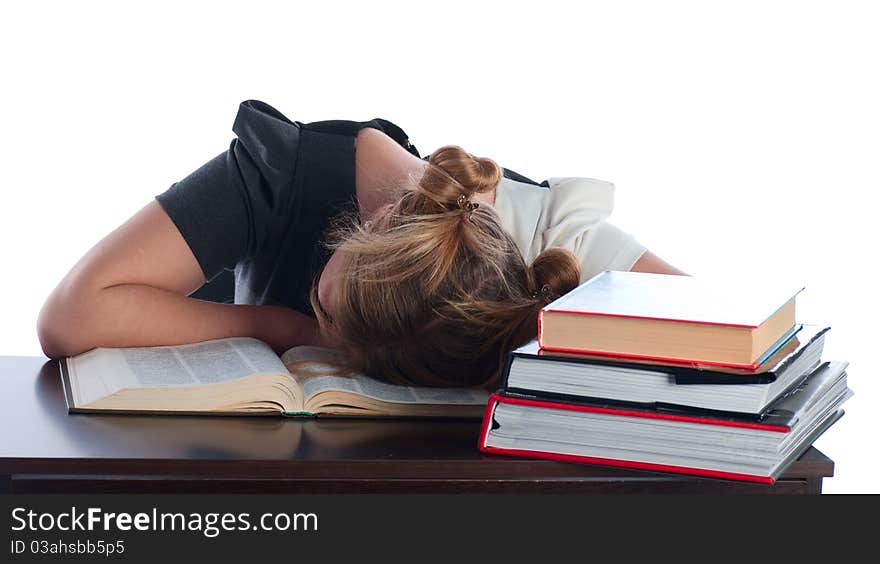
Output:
[{"left": 69, "top": 337, "right": 287, "bottom": 405}]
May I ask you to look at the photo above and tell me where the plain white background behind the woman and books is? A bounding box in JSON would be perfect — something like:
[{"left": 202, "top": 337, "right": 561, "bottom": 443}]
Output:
[{"left": 0, "top": 0, "right": 880, "bottom": 492}]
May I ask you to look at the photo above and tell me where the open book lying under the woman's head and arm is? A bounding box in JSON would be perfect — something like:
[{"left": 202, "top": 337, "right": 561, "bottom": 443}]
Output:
[{"left": 60, "top": 337, "right": 489, "bottom": 417}]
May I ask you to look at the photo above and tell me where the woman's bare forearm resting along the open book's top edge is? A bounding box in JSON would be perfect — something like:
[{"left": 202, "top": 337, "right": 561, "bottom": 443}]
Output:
[{"left": 37, "top": 284, "right": 317, "bottom": 358}]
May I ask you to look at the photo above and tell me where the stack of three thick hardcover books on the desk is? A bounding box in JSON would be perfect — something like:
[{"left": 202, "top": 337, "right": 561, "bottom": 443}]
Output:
[{"left": 479, "top": 271, "right": 852, "bottom": 483}]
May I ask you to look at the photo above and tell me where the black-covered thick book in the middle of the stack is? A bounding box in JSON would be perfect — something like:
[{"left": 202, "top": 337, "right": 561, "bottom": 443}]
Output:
[{"left": 501, "top": 325, "right": 830, "bottom": 413}]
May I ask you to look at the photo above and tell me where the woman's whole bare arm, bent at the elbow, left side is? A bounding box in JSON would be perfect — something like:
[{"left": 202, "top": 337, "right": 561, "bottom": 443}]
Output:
[{"left": 37, "top": 200, "right": 319, "bottom": 358}]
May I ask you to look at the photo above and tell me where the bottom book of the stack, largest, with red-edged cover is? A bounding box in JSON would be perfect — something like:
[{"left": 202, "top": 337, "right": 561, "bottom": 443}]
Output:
[{"left": 479, "top": 361, "right": 852, "bottom": 483}]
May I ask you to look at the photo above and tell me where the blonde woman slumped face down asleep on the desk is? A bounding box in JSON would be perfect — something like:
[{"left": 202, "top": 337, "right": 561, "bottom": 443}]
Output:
[{"left": 38, "top": 100, "right": 683, "bottom": 386}]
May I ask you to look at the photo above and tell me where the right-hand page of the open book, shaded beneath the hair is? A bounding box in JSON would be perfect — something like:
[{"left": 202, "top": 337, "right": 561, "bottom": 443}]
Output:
[{"left": 281, "top": 346, "right": 489, "bottom": 405}]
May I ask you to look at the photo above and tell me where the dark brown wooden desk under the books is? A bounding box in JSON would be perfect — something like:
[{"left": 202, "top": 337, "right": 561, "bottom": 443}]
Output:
[{"left": 0, "top": 357, "right": 834, "bottom": 493}]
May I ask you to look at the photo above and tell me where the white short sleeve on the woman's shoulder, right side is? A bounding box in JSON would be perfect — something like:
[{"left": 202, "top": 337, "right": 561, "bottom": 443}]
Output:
[{"left": 541, "top": 178, "right": 647, "bottom": 282}]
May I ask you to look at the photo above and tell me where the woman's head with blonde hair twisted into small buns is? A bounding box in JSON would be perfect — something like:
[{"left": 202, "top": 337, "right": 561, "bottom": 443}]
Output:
[{"left": 311, "top": 146, "right": 579, "bottom": 386}]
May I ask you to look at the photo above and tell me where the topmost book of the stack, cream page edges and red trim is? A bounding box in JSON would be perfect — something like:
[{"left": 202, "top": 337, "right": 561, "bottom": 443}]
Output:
[{"left": 538, "top": 270, "right": 803, "bottom": 370}]
